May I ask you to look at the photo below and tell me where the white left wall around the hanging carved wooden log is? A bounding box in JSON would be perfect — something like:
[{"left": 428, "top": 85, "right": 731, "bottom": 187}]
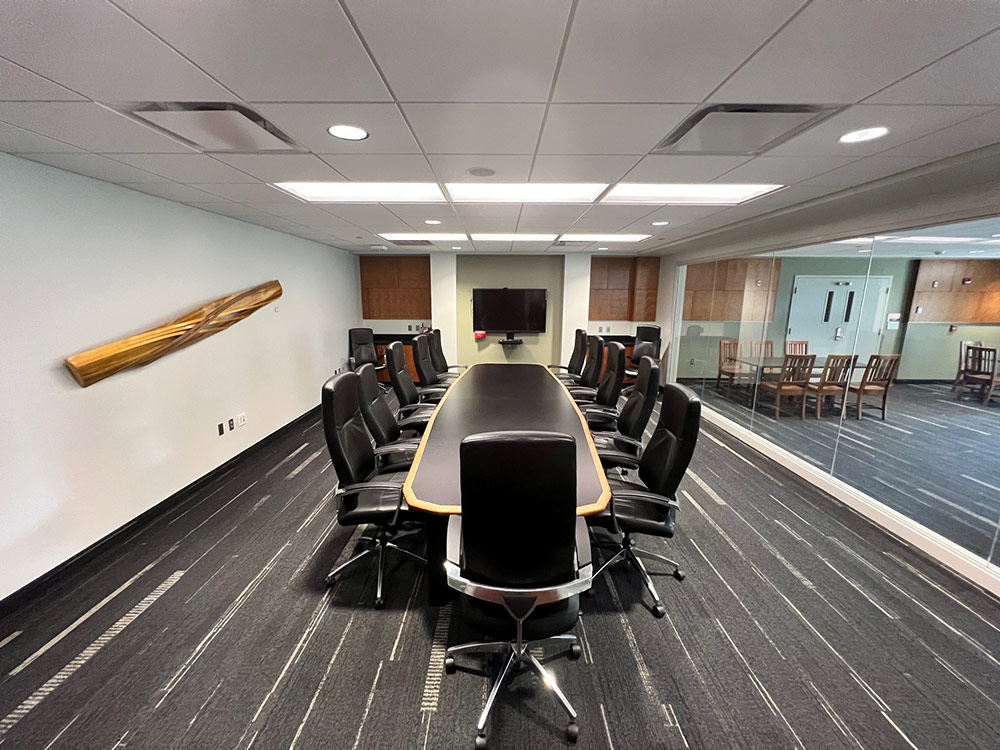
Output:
[{"left": 0, "top": 154, "right": 360, "bottom": 597}]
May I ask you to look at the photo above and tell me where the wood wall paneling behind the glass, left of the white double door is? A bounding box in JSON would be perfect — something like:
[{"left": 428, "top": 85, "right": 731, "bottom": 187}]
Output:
[{"left": 683, "top": 258, "right": 781, "bottom": 322}]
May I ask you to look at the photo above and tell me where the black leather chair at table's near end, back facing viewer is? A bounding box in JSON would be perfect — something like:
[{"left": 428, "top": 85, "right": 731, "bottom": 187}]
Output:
[{"left": 445, "top": 432, "right": 592, "bottom": 748}]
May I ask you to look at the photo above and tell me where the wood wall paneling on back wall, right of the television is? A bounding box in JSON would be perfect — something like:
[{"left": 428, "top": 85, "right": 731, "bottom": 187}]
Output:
[{"left": 589, "top": 255, "right": 660, "bottom": 321}]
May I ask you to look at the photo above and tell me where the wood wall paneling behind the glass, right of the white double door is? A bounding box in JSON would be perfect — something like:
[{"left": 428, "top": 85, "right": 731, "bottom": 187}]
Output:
[{"left": 910, "top": 258, "right": 1000, "bottom": 323}]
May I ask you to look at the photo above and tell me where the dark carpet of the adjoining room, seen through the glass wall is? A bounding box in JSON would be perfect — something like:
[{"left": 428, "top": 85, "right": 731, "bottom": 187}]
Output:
[{"left": 688, "top": 380, "right": 1000, "bottom": 563}]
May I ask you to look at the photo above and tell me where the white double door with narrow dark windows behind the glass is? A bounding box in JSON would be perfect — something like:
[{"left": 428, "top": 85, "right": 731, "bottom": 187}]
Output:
[{"left": 785, "top": 276, "right": 892, "bottom": 363}]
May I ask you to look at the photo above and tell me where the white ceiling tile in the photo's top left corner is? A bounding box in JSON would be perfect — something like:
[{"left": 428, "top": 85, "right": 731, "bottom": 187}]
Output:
[{"left": 0, "top": 0, "right": 232, "bottom": 102}]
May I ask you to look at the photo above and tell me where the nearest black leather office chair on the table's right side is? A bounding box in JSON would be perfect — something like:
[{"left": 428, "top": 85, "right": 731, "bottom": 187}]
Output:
[{"left": 587, "top": 383, "right": 701, "bottom": 617}]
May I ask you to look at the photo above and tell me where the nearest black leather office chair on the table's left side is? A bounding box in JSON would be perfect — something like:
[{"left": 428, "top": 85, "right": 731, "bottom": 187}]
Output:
[{"left": 322, "top": 372, "right": 426, "bottom": 609}]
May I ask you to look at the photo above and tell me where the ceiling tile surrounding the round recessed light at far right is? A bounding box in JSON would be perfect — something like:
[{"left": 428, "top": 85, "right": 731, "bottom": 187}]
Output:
[{"left": 766, "top": 104, "right": 989, "bottom": 159}]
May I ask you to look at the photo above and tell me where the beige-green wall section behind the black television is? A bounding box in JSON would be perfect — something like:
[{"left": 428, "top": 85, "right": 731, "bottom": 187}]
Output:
[{"left": 456, "top": 255, "right": 564, "bottom": 365}]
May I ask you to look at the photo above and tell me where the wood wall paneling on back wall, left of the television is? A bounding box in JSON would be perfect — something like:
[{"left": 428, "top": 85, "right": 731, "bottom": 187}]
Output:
[{"left": 359, "top": 255, "right": 431, "bottom": 320}]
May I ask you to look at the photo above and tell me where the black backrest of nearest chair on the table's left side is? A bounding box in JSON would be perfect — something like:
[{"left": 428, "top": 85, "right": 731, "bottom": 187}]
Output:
[{"left": 321, "top": 372, "right": 375, "bottom": 486}]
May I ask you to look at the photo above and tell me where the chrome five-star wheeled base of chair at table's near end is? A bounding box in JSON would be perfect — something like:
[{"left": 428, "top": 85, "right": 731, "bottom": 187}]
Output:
[{"left": 444, "top": 633, "right": 583, "bottom": 750}]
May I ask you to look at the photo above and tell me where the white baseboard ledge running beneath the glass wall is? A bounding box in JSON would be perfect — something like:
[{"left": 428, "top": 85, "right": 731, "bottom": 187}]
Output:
[{"left": 702, "top": 405, "right": 1000, "bottom": 597}]
